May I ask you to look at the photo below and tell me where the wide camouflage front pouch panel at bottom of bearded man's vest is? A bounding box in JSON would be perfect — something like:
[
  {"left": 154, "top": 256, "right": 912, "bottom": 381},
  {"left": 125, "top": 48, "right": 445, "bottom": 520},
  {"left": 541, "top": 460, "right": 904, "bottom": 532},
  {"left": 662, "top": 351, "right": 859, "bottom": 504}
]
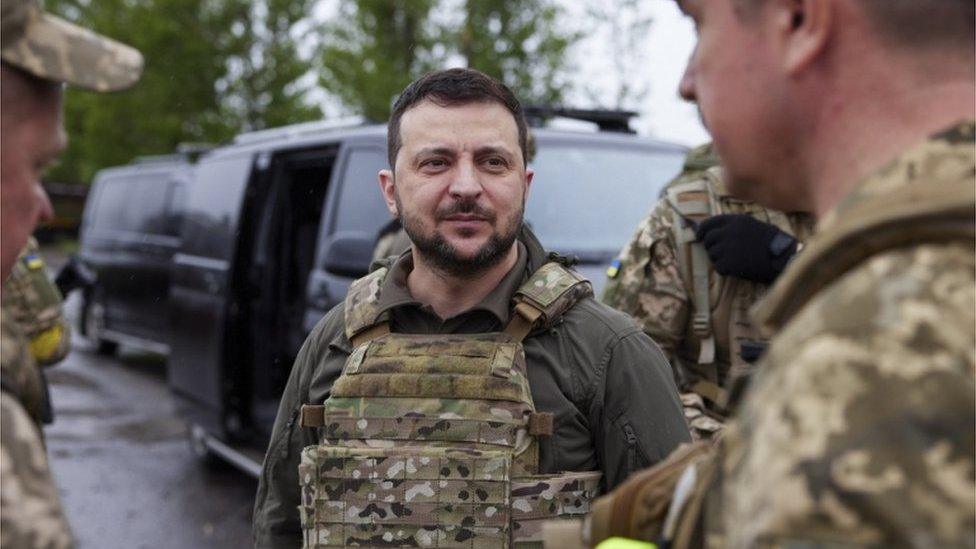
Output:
[{"left": 299, "top": 445, "right": 512, "bottom": 548}]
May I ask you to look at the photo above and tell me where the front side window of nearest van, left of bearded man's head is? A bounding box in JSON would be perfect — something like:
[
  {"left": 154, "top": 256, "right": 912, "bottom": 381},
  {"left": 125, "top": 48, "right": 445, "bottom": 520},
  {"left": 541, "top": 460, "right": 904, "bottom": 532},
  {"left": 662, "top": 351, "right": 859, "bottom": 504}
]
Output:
[{"left": 334, "top": 147, "right": 390, "bottom": 238}]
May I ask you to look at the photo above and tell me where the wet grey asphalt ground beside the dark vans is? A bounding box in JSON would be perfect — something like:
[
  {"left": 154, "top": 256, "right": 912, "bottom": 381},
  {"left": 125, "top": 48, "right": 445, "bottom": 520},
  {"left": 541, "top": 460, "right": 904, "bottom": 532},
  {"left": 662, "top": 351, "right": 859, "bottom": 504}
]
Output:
[{"left": 45, "top": 297, "right": 257, "bottom": 549}]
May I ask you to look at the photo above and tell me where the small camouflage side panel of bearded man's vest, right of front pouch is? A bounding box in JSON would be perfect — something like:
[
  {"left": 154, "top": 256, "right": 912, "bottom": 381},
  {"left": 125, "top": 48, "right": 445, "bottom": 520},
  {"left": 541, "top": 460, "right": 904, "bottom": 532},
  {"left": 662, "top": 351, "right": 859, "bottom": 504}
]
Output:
[{"left": 512, "top": 471, "right": 603, "bottom": 549}]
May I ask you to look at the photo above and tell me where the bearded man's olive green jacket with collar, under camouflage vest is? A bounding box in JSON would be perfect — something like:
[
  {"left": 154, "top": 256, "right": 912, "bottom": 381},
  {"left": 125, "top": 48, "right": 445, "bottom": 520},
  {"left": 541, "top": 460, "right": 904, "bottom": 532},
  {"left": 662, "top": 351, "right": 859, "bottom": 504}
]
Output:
[{"left": 254, "top": 232, "right": 690, "bottom": 547}]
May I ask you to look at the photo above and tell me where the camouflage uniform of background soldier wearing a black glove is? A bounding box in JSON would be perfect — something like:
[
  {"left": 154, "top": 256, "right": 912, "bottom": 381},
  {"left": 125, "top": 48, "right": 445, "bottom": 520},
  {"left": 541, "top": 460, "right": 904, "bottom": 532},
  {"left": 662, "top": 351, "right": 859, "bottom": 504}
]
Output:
[{"left": 602, "top": 145, "right": 812, "bottom": 438}]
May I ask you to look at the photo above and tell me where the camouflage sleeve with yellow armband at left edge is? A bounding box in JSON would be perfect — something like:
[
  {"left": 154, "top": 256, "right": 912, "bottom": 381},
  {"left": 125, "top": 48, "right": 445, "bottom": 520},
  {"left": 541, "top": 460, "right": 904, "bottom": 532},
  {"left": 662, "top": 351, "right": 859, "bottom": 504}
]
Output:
[{"left": 0, "top": 237, "right": 71, "bottom": 366}]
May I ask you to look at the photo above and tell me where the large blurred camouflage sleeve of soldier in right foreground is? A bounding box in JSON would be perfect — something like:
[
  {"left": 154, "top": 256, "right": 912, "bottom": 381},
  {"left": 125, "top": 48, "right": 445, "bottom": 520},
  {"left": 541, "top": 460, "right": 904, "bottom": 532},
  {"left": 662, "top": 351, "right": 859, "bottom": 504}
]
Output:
[{"left": 706, "top": 245, "right": 976, "bottom": 547}]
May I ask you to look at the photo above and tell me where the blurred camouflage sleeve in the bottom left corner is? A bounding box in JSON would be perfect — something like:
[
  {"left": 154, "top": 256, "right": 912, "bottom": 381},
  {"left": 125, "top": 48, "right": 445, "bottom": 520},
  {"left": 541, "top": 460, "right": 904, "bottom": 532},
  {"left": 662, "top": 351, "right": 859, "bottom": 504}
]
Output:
[{"left": 0, "top": 391, "right": 72, "bottom": 549}]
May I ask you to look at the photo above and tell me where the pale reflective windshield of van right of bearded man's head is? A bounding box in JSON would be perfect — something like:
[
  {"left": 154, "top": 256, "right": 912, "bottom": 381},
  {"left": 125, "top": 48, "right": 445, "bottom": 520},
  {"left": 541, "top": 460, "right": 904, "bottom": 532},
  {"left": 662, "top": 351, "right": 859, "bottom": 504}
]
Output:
[{"left": 525, "top": 143, "right": 684, "bottom": 262}]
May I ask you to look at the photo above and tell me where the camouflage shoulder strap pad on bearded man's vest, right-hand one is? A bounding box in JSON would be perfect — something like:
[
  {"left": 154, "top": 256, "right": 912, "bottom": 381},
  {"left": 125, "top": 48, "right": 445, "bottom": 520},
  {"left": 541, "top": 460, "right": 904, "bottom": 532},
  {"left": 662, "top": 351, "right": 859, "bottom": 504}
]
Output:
[{"left": 505, "top": 261, "right": 593, "bottom": 341}]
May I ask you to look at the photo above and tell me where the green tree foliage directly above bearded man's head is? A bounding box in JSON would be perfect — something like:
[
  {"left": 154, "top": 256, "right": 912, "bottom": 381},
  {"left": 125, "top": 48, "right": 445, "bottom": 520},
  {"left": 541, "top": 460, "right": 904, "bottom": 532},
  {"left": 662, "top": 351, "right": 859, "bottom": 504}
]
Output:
[{"left": 320, "top": 0, "right": 579, "bottom": 121}]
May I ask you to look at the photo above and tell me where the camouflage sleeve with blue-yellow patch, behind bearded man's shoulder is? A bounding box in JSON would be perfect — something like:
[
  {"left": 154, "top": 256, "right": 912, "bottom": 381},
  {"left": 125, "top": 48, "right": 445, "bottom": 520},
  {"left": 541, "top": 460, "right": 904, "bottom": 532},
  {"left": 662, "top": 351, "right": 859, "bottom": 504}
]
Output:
[{"left": 602, "top": 201, "right": 689, "bottom": 362}]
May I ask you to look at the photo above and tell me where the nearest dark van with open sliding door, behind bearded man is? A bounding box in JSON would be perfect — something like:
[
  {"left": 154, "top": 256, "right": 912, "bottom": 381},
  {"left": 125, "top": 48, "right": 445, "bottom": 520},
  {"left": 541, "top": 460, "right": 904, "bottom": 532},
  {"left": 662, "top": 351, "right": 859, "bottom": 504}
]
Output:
[{"left": 169, "top": 114, "right": 685, "bottom": 475}]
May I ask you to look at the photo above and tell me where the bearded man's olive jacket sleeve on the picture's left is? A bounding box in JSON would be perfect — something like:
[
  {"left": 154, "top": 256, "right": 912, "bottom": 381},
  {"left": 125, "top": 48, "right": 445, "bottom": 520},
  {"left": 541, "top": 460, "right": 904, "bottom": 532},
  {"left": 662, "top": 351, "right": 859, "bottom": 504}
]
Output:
[{"left": 253, "top": 305, "right": 342, "bottom": 549}]
